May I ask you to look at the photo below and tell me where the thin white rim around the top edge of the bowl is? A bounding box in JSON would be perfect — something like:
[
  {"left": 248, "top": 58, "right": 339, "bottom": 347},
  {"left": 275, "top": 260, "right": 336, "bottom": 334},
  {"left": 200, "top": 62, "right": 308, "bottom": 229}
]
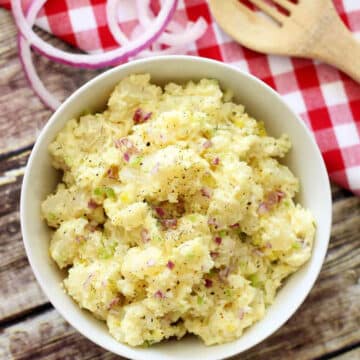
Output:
[{"left": 20, "top": 55, "right": 332, "bottom": 360}]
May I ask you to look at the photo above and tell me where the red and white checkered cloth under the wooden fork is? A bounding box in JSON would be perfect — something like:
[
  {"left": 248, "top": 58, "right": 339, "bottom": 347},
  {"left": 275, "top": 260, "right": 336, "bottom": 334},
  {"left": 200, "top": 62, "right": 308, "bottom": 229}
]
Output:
[{"left": 0, "top": 0, "right": 360, "bottom": 195}]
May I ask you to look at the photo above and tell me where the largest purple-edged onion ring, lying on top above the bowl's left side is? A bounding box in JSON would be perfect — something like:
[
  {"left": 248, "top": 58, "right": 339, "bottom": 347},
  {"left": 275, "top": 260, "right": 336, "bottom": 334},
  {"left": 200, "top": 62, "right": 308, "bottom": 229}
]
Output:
[{"left": 11, "top": 0, "right": 178, "bottom": 69}]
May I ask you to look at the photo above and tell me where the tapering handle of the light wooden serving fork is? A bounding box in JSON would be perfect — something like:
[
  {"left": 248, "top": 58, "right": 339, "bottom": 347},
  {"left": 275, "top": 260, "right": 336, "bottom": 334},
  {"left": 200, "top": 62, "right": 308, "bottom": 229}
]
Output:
[{"left": 308, "top": 10, "right": 360, "bottom": 83}]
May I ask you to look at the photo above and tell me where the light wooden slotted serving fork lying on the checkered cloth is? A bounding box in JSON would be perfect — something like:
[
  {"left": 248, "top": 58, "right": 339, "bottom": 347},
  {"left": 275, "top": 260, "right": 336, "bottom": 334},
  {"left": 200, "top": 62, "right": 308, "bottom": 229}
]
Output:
[{"left": 210, "top": 0, "right": 360, "bottom": 82}]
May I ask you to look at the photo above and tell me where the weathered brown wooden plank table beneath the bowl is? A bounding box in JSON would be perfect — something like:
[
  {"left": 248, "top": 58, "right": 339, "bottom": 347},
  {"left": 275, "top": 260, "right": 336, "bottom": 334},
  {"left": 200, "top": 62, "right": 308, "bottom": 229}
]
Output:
[{"left": 0, "top": 10, "right": 360, "bottom": 360}]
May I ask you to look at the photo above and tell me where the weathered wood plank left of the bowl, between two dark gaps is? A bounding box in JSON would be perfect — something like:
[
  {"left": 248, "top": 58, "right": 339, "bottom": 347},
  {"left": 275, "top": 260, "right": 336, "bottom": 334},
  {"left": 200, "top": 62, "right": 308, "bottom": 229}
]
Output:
[{"left": 0, "top": 152, "right": 48, "bottom": 321}]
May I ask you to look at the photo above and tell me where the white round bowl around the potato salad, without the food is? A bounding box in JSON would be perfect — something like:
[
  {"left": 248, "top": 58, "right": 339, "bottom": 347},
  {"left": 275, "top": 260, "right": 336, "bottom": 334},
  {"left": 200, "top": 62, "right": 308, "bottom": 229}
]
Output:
[{"left": 20, "top": 56, "right": 331, "bottom": 360}]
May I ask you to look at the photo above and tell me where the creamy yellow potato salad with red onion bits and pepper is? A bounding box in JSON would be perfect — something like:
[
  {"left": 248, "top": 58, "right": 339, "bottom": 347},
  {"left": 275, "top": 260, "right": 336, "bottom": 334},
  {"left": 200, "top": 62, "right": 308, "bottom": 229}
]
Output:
[{"left": 41, "top": 74, "right": 315, "bottom": 346}]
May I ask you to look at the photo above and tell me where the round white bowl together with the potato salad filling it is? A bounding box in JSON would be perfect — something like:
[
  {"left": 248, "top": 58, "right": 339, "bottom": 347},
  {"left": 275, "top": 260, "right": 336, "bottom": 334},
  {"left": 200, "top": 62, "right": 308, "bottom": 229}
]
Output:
[{"left": 21, "top": 56, "right": 331, "bottom": 359}]
